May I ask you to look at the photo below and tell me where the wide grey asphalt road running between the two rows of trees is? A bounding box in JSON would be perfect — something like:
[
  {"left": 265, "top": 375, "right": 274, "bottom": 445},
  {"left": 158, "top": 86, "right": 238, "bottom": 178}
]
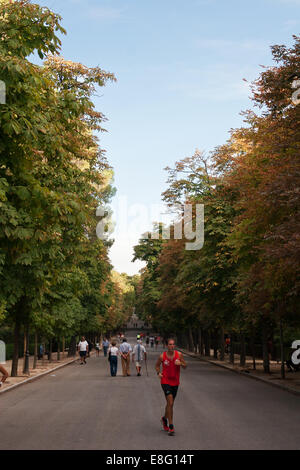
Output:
[{"left": 0, "top": 332, "right": 300, "bottom": 450}]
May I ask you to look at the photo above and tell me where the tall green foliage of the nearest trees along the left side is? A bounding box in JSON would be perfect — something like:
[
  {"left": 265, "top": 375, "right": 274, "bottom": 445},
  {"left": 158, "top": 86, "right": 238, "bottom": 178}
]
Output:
[{"left": 0, "top": 0, "right": 122, "bottom": 370}]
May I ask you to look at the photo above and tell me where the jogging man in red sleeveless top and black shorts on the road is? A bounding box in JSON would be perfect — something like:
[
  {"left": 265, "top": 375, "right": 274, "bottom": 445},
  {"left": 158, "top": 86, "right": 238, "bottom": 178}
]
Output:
[{"left": 155, "top": 338, "right": 187, "bottom": 436}]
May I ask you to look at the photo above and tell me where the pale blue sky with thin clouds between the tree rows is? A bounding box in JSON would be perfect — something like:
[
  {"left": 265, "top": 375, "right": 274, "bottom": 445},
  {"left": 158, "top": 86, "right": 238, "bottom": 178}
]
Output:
[{"left": 33, "top": 0, "right": 300, "bottom": 274}]
